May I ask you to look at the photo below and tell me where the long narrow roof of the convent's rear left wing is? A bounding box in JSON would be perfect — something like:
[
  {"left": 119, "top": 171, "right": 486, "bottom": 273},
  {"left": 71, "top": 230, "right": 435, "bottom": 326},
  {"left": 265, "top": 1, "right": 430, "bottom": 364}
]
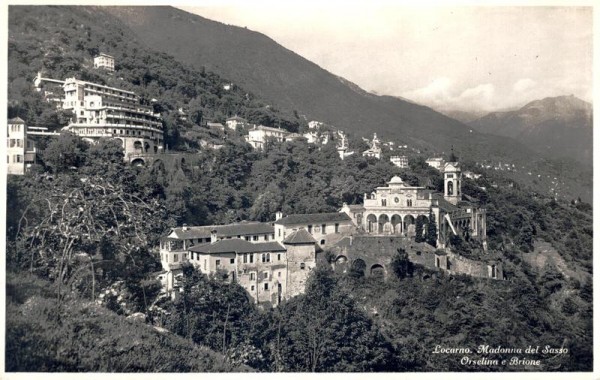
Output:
[{"left": 169, "top": 222, "right": 275, "bottom": 239}]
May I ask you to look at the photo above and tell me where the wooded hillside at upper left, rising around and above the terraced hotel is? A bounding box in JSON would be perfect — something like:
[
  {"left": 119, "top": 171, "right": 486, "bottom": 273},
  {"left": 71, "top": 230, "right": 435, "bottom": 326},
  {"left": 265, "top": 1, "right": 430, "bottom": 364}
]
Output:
[{"left": 8, "top": 6, "right": 300, "bottom": 149}]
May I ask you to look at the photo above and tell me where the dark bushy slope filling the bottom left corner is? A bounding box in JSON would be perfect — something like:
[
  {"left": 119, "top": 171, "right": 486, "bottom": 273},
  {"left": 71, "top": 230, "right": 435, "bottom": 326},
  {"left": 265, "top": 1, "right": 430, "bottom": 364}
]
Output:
[{"left": 5, "top": 272, "right": 252, "bottom": 372}]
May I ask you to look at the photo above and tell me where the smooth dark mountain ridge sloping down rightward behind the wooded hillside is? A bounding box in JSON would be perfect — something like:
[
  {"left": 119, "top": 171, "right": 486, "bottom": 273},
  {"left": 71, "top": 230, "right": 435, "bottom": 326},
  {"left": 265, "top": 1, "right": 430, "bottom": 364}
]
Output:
[{"left": 98, "top": 7, "right": 592, "bottom": 201}]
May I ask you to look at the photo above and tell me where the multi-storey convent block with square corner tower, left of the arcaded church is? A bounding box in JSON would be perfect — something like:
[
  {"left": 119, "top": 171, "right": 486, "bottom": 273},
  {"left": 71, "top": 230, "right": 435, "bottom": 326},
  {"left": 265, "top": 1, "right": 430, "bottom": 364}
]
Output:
[{"left": 158, "top": 222, "right": 320, "bottom": 305}]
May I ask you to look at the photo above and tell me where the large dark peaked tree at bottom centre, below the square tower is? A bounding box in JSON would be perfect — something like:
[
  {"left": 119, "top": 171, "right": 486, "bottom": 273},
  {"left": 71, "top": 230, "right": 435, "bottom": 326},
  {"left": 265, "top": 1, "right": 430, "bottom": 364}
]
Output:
[{"left": 273, "top": 267, "right": 395, "bottom": 372}]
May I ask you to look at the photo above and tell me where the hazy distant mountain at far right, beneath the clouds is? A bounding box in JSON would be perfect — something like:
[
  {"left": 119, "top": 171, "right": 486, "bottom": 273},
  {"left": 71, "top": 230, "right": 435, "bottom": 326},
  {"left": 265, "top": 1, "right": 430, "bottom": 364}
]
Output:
[{"left": 469, "top": 95, "right": 593, "bottom": 165}]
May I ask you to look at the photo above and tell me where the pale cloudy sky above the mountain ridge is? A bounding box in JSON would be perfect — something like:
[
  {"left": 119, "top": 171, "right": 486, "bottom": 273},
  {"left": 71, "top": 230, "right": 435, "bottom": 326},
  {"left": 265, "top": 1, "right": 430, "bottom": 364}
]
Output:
[{"left": 180, "top": 2, "right": 593, "bottom": 111}]
